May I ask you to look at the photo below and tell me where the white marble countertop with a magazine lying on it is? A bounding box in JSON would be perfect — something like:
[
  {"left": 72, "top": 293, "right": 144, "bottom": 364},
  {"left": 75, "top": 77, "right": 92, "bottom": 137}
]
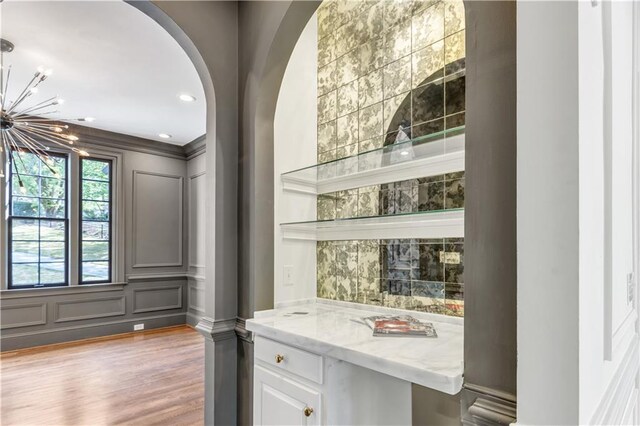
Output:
[{"left": 246, "top": 301, "right": 464, "bottom": 395}]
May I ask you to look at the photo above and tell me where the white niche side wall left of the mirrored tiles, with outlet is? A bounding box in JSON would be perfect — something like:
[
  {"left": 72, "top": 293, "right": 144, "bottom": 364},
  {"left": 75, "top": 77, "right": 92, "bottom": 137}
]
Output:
[{"left": 273, "top": 15, "right": 318, "bottom": 303}]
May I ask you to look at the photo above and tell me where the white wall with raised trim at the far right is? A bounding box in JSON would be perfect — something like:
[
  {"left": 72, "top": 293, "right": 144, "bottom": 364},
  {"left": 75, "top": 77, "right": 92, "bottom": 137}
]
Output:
[{"left": 517, "top": 2, "right": 640, "bottom": 425}]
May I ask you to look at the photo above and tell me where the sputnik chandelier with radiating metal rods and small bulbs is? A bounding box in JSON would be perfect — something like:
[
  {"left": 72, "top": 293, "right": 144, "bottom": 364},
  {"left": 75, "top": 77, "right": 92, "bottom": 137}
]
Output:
[{"left": 0, "top": 39, "right": 89, "bottom": 181}]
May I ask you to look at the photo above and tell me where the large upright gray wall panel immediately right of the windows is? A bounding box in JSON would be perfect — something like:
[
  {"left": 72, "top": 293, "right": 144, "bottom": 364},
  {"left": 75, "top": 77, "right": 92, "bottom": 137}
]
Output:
[{"left": 132, "top": 170, "right": 184, "bottom": 268}]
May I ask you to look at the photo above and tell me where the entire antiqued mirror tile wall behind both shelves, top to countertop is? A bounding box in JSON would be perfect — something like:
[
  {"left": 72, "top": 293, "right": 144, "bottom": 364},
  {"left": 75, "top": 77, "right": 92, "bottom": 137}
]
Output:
[{"left": 317, "top": 0, "right": 465, "bottom": 316}]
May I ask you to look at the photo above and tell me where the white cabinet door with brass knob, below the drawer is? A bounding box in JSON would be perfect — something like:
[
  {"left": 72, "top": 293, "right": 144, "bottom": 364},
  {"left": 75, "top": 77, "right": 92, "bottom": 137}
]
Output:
[{"left": 253, "top": 365, "right": 320, "bottom": 425}]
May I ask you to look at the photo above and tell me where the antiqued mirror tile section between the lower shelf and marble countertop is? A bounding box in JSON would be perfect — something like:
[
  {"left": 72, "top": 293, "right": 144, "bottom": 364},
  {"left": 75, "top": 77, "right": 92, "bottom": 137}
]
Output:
[{"left": 317, "top": 238, "right": 464, "bottom": 316}]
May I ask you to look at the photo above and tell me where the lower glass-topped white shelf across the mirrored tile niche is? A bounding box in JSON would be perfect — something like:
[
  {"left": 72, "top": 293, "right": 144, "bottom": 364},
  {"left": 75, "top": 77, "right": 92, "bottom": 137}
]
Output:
[{"left": 280, "top": 209, "right": 464, "bottom": 241}]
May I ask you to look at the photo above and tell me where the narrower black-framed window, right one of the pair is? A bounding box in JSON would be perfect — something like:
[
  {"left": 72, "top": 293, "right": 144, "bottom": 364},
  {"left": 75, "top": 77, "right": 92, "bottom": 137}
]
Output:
[{"left": 79, "top": 158, "right": 113, "bottom": 284}]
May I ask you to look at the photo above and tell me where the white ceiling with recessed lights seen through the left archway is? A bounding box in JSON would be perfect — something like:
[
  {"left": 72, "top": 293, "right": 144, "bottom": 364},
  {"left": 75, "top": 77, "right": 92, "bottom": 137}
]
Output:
[{"left": 0, "top": 0, "right": 206, "bottom": 145}]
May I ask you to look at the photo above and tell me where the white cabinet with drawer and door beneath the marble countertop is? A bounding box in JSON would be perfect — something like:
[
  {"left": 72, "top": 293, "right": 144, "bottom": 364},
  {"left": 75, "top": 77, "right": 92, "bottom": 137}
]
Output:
[{"left": 253, "top": 335, "right": 411, "bottom": 426}]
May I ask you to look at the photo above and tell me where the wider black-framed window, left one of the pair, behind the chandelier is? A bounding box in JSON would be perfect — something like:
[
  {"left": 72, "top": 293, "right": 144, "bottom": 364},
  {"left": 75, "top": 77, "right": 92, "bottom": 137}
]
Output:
[{"left": 8, "top": 151, "right": 69, "bottom": 289}]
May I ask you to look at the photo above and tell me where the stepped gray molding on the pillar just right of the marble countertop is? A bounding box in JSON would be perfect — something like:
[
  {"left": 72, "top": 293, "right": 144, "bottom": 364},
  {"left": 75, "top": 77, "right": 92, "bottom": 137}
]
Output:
[{"left": 462, "top": 383, "right": 517, "bottom": 426}]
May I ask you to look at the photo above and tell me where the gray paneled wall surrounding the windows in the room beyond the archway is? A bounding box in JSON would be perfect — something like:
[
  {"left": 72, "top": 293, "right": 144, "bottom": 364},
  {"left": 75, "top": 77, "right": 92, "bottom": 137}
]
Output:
[{"left": 0, "top": 127, "right": 203, "bottom": 350}]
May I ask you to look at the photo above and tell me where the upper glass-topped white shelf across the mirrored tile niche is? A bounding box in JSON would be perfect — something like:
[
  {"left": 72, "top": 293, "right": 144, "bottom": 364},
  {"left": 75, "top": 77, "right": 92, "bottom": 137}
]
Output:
[{"left": 281, "top": 126, "right": 465, "bottom": 194}]
